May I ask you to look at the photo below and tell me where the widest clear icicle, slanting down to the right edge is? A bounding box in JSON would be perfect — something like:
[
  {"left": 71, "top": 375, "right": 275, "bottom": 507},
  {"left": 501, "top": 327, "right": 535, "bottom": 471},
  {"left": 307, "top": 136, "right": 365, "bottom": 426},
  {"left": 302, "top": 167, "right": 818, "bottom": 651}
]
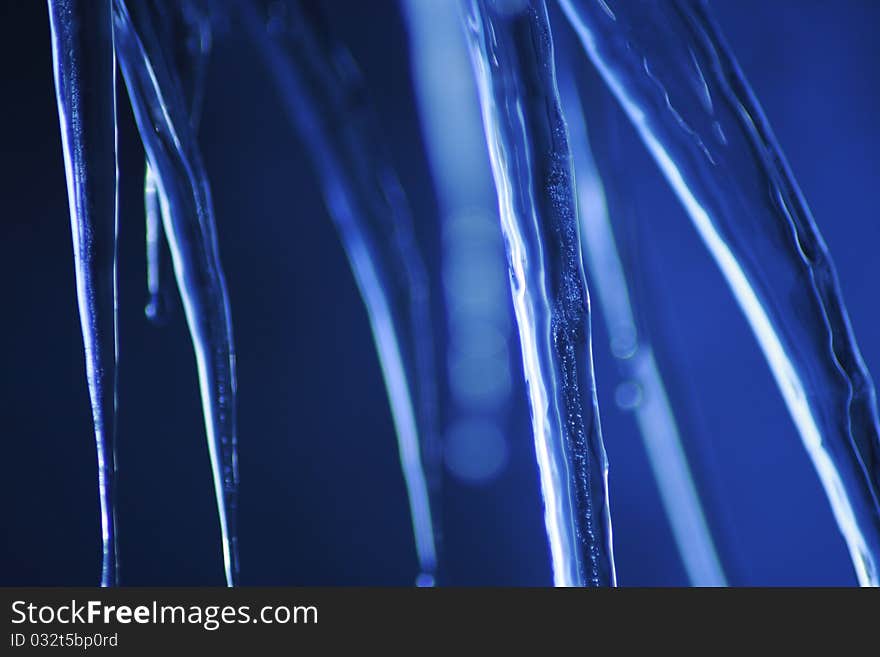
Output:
[{"left": 561, "top": 0, "right": 880, "bottom": 585}]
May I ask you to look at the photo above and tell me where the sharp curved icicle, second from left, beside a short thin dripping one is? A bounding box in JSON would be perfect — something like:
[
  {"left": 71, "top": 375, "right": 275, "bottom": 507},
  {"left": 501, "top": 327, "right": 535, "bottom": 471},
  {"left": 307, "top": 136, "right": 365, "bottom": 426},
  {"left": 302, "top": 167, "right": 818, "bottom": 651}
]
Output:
[{"left": 113, "top": 0, "right": 238, "bottom": 586}]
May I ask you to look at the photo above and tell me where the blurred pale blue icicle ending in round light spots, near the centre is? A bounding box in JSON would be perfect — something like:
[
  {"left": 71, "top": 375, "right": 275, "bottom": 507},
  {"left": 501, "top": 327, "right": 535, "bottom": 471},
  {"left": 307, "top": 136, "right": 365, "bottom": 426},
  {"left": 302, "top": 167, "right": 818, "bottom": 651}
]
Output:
[{"left": 402, "top": 0, "right": 512, "bottom": 484}]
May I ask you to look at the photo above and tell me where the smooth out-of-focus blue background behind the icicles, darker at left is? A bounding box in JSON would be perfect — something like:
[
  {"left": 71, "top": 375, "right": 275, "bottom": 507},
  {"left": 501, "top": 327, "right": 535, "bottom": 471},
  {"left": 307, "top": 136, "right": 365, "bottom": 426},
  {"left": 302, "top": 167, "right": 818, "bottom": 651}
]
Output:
[{"left": 0, "top": 0, "right": 880, "bottom": 586}]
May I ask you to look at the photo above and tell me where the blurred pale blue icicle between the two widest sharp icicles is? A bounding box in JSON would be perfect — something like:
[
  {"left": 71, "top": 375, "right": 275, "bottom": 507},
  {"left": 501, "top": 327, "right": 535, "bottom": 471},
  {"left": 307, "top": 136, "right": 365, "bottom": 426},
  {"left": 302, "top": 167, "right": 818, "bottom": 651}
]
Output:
[{"left": 559, "top": 61, "right": 727, "bottom": 586}]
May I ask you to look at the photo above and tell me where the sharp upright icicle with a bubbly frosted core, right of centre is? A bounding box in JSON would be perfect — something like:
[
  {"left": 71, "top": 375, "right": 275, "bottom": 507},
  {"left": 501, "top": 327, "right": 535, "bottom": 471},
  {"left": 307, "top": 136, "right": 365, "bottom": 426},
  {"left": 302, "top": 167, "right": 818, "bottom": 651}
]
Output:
[{"left": 465, "top": 0, "right": 615, "bottom": 586}]
